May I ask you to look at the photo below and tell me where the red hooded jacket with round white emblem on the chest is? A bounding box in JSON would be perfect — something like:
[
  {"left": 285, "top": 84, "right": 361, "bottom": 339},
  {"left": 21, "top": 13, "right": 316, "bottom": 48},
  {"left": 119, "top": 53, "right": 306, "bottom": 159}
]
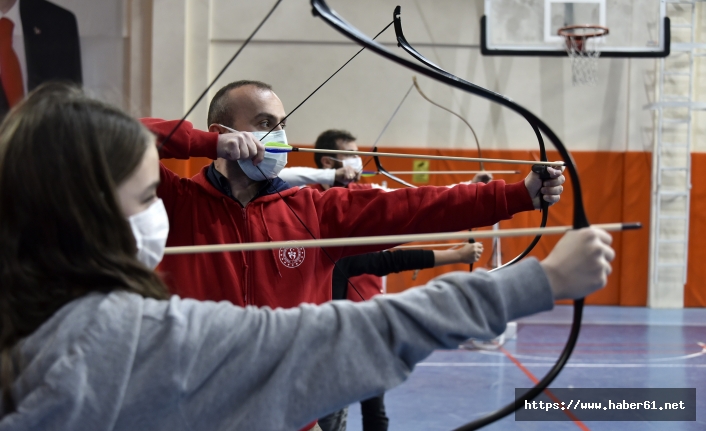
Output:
[{"left": 143, "top": 119, "right": 534, "bottom": 308}]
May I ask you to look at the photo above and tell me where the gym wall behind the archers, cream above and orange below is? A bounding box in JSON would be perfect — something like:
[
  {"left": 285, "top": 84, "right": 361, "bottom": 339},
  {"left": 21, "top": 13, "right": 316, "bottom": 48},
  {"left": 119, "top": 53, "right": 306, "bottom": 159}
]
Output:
[{"left": 119, "top": 0, "right": 706, "bottom": 307}]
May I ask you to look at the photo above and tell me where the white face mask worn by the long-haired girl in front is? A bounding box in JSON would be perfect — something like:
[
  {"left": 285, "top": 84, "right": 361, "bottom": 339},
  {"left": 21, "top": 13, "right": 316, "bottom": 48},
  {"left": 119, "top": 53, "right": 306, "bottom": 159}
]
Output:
[{"left": 128, "top": 199, "right": 169, "bottom": 269}]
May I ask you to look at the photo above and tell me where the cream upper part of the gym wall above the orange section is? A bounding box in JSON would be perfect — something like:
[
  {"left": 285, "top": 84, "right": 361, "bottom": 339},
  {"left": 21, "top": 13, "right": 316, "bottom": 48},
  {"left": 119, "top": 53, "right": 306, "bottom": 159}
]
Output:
[{"left": 144, "top": 0, "right": 676, "bottom": 151}]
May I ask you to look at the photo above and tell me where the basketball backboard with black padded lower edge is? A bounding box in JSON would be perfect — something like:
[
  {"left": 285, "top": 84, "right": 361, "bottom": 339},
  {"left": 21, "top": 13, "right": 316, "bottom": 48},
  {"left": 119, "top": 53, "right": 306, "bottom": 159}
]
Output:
[{"left": 481, "top": 0, "right": 670, "bottom": 57}]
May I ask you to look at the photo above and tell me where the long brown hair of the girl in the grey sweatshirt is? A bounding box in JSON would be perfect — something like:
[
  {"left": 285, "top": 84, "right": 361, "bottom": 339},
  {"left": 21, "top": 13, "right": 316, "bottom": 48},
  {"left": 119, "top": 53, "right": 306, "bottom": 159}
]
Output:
[{"left": 0, "top": 84, "right": 168, "bottom": 413}]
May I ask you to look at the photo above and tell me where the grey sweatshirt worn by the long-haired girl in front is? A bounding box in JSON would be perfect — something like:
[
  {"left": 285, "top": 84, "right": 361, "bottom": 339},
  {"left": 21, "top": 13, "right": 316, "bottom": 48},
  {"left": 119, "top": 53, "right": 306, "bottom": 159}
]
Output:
[{"left": 0, "top": 259, "right": 553, "bottom": 431}]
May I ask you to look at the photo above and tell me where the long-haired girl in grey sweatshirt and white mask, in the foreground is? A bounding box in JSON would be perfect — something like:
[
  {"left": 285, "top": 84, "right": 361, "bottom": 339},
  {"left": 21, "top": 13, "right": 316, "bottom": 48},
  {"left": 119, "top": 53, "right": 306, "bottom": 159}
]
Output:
[{"left": 0, "top": 85, "right": 615, "bottom": 431}]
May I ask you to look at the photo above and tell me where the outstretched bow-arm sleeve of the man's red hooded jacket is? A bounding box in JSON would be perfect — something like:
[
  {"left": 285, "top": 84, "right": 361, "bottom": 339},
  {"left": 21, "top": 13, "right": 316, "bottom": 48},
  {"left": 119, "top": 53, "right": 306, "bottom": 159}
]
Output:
[{"left": 312, "top": 181, "right": 534, "bottom": 258}]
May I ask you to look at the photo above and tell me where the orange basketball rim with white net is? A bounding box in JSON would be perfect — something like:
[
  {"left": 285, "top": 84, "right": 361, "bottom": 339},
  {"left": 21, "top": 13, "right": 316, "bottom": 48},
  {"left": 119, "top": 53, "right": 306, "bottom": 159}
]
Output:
[{"left": 557, "top": 24, "right": 609, "bottom": 85}]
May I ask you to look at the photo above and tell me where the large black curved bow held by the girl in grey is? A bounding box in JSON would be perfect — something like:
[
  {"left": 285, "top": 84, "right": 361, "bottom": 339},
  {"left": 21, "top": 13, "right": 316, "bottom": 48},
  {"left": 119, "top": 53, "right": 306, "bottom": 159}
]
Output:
[{"left": 311, "top": 0, "right": 589, "bottom": 431}]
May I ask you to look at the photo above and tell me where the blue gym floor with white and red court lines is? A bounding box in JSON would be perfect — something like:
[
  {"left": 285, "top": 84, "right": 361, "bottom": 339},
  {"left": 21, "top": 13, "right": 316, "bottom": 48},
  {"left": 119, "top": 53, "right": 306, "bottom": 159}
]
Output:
[{"left": 348, "top": 306, "right": 706, "bottom": 431}]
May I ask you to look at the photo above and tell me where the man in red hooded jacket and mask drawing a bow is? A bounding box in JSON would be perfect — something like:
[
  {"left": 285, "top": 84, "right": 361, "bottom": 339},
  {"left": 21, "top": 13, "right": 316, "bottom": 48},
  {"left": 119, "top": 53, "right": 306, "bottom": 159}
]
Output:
[{"left": 144, "top": 81, "right": 564, "bottom": 308}]
